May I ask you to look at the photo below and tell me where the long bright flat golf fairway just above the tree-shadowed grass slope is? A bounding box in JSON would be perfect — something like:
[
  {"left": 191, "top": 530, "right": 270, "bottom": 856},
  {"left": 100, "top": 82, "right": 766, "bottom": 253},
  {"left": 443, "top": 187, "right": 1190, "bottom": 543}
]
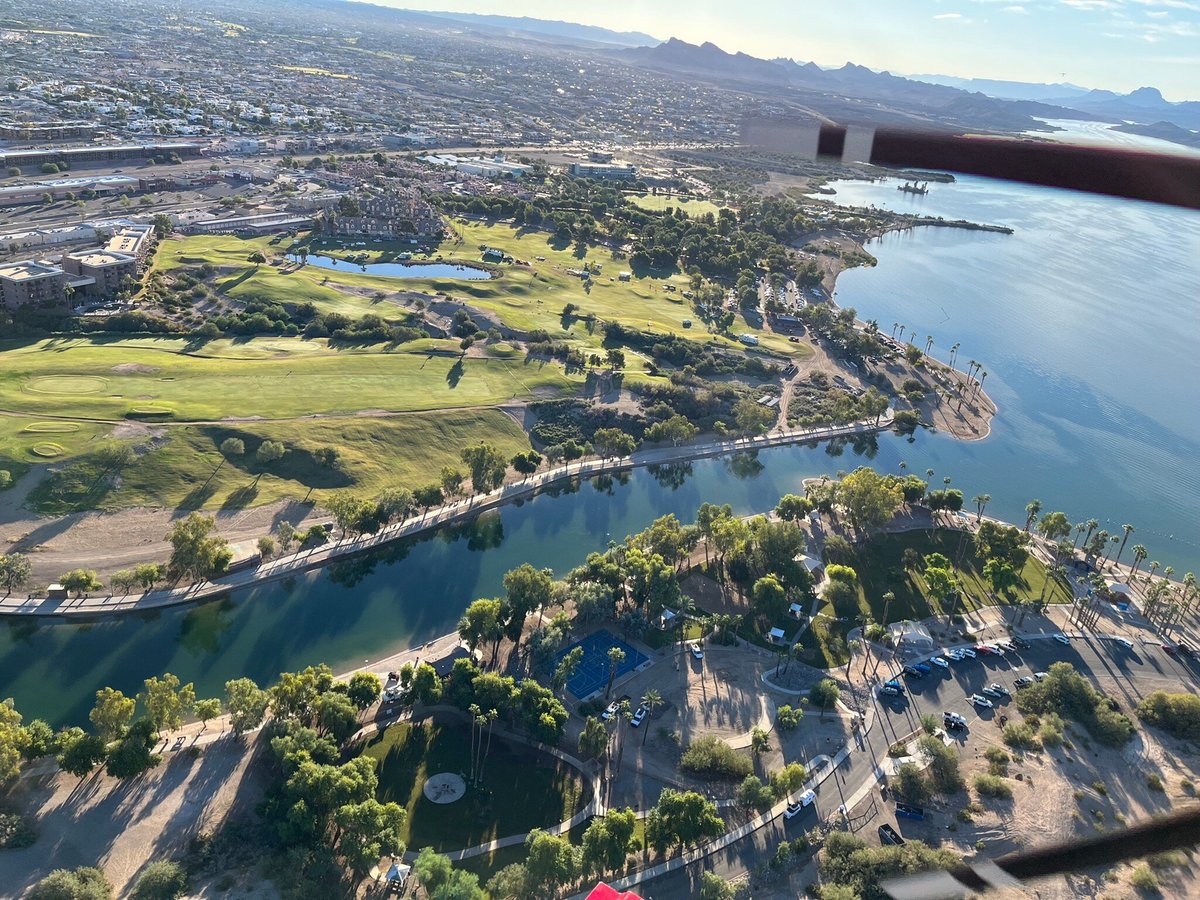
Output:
[{"left": 0, "top": 338, "right": 581, "bottom": 421}]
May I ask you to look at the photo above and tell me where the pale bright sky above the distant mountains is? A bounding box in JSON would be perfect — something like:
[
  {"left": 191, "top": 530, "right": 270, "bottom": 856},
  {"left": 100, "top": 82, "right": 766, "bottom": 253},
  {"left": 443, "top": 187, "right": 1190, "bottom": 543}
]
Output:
[{"left": 386, "top": 0, "right": 1200, "bottom": 101}]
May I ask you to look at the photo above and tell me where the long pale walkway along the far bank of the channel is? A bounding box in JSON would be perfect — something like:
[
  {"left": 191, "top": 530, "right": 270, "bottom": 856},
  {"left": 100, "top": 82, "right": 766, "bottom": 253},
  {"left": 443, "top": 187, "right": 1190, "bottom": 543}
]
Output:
[{"left": 0, "top": 409, "right": 893, "bottom": 618}]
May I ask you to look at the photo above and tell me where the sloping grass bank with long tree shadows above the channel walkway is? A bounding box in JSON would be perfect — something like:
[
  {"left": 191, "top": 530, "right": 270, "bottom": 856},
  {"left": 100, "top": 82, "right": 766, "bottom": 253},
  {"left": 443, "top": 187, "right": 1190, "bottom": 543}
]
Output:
[{"left": 22, "top": 409, "right": 529, "bottom": 515}]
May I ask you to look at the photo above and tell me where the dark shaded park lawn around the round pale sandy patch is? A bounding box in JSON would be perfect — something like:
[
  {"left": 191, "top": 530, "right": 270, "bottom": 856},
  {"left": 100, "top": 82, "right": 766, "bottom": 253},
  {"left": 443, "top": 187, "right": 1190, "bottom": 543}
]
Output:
[{"left": 362, "top": 721, "right": 587, "bottom": 852}]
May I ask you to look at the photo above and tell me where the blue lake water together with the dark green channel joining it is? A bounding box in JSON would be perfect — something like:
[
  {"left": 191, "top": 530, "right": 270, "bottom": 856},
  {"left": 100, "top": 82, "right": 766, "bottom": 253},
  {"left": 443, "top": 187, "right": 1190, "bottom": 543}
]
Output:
[{"left": 9, "top": 164, "right": 1200, "bottom": 724}]
